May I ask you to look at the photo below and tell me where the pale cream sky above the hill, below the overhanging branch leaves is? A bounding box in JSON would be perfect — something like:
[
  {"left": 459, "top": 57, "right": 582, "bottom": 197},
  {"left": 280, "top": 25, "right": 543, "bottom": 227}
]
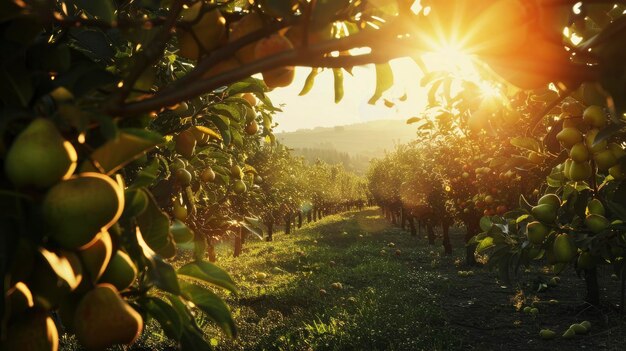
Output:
[{"left": 268, "top": 59, "right": 426, "bottom": 132}]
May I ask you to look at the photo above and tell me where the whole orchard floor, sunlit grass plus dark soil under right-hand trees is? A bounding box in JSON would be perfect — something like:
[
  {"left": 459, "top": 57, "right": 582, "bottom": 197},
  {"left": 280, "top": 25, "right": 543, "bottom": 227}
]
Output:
[{"left": 133, "top": 209, "right": 626, "bottom": 351}]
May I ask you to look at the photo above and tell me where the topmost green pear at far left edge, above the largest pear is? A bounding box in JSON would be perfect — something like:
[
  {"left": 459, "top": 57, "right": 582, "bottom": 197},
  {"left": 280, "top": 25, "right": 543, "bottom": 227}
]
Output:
[{"left": 4, "top": 118, "right": 77, "bottom": 189}]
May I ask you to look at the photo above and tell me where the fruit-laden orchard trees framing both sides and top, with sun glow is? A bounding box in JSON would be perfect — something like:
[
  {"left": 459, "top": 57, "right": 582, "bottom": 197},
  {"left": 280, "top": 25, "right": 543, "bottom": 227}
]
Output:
[{"left": 0, "top": 0, "right": 626, "bottom": 350}]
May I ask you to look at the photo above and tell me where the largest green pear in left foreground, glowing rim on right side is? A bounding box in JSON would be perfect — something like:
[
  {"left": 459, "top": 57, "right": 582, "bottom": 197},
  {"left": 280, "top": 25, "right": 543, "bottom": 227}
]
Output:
[{"left": 42, "top": 172, "right": 124, "bottom": 249}]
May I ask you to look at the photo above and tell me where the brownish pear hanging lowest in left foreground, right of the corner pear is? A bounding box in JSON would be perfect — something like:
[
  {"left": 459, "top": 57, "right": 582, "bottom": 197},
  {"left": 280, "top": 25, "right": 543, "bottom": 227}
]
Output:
[{"left": 74, "top": 284, "right": 143, "bottom": 350}]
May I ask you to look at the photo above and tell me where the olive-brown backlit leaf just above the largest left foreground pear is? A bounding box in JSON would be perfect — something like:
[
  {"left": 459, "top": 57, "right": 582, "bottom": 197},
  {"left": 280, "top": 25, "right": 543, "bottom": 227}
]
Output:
[{"left": 80, "top": 129, "right": 163, "bottom": 175}]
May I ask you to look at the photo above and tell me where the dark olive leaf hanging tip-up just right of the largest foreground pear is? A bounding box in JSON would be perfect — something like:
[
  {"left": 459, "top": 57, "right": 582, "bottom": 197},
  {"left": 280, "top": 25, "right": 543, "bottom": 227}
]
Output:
[{"left": 137, "top": 194, "right": 173, "bottom": 251}]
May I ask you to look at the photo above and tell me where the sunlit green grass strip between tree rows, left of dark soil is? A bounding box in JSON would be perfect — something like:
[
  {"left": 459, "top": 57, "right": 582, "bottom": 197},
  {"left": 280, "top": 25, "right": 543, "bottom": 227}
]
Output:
[{"left": 206, "top": 210, "right": 455, "bottom": 350}]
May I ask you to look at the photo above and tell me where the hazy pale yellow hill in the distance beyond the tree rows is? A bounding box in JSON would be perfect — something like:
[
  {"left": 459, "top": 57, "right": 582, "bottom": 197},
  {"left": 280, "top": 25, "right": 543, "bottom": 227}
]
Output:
[{"left": 276, "top": 120, "right": 416, "bottom": 174}]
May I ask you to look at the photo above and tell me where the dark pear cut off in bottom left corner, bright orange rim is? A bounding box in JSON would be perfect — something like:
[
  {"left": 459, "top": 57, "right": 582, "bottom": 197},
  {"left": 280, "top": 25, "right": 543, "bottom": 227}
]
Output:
[{"left": 0, "top": 310, "right": 59, "bottom": 351}]
